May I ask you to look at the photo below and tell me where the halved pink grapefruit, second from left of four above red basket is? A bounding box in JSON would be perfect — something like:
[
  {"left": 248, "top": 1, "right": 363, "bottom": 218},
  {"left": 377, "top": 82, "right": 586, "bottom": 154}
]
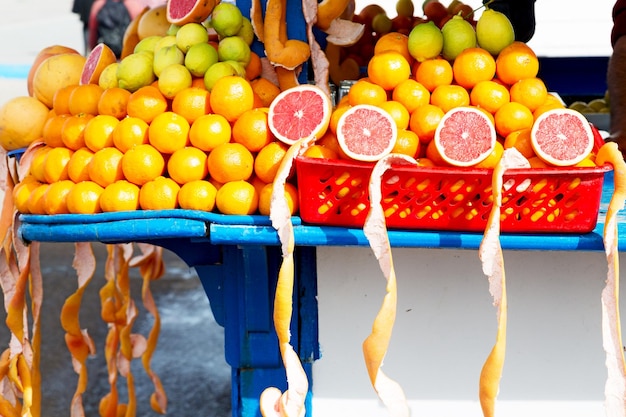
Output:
[{"left": 337, "top": 104, "right": 398, "bottom": 162}]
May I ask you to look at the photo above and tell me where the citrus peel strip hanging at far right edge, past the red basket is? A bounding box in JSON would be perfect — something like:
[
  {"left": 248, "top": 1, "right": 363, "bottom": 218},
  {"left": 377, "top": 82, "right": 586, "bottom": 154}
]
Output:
[{"left": 596, "top": 142, "right": 626, "bottom": 416}]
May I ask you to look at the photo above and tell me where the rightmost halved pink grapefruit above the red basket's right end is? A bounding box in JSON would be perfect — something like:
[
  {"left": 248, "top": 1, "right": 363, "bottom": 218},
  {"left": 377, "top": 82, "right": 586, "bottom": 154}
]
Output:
[{"left": 530, "top": 108, "right": 594, "bottom": 166}]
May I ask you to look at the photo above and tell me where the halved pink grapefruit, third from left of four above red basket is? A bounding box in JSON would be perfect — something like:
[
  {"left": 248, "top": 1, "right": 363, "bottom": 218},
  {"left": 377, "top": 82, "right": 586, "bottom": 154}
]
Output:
[{"left": 434, "top": 107, "right": 496, "bottom": 167}]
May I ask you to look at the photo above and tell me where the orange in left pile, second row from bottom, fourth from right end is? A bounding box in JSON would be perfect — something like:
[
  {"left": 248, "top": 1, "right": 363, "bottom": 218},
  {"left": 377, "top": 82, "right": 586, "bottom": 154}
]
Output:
[{"left": 122, "top": 143, "right": 165, "bottom": 186}]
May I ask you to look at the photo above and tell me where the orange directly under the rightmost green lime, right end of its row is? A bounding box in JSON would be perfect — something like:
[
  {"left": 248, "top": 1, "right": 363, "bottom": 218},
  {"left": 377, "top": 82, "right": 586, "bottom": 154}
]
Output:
[{"left": 496, "top": 41, "right": 539, "bottom": 85}]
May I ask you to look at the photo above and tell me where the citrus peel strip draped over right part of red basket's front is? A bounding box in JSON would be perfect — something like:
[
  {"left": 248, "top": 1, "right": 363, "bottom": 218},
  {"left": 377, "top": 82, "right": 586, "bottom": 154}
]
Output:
[{"left": 478, "top": 148, "right": 530, "bottom": 417}]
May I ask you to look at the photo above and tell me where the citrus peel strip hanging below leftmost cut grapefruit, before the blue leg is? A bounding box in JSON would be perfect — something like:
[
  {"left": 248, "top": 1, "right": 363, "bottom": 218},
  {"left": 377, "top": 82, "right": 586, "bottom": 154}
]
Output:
[{"left": 259, "top": 138, "right": 315, "bottom": 417}]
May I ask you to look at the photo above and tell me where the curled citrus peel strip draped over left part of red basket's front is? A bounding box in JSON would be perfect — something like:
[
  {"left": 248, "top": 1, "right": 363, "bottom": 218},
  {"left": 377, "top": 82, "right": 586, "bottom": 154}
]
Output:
[{"left": 363, "top": 154, "right": 417, "bottom": 417}]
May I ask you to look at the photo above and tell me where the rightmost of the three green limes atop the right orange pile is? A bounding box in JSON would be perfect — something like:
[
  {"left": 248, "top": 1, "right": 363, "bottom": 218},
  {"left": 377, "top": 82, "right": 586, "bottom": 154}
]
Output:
[{"left": 476, "top": 9, "right": 515, "bottom": 56}]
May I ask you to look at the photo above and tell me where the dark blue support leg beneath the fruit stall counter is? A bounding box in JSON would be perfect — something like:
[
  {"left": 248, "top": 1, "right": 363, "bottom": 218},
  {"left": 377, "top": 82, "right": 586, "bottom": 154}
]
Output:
[{"left": 163, "top": 240, "right": 319, "bottom": 417}]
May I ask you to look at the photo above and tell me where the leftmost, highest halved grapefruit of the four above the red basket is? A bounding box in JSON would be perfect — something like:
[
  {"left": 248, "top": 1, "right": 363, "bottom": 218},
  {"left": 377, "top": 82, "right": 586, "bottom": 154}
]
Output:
[{"left": 267, "top": 84, "right": 333, "bottom": 145}]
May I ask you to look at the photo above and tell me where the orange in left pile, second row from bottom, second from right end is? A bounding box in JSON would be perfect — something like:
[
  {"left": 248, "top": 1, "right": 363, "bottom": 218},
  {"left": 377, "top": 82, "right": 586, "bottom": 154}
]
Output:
[{"left": 207, "top": 143, "right": 252, "bottom": 184}]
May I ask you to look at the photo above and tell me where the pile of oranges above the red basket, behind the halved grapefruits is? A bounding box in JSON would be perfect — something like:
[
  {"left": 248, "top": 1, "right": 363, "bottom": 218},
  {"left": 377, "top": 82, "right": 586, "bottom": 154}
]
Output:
[{"left": 314, "top": 33, "right": 593, "bottom": 168}]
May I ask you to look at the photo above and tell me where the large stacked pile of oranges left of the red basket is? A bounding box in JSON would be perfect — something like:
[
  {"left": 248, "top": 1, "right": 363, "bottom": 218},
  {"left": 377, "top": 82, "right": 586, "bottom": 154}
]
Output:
[{"left": 14, "top": 76, "right": 297, "bottom": 215}]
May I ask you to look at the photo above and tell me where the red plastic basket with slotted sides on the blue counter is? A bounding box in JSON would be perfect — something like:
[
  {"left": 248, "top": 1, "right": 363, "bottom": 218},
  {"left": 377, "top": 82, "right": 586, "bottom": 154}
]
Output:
[{"left": 296, "top": 157, "right": 610, "bottom": 233}]
